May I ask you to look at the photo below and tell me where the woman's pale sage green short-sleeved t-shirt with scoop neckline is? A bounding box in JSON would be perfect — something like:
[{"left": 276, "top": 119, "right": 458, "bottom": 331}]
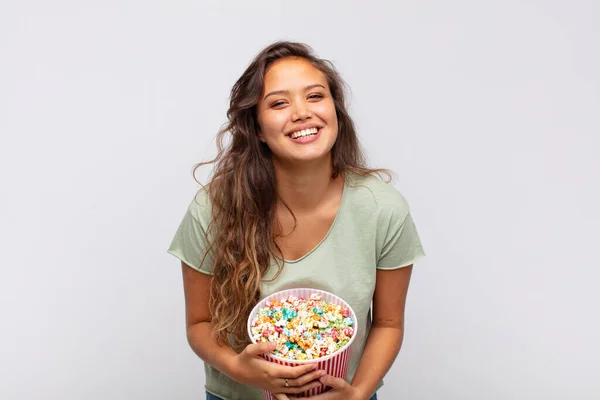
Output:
[{"left": 168, "top": 174, "right": 425, "bottom": 400}]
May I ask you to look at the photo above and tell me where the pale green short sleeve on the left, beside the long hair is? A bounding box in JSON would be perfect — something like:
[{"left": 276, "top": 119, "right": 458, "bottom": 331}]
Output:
[{"left": 168, "top": 190, "right": 214, "bottom": 275}]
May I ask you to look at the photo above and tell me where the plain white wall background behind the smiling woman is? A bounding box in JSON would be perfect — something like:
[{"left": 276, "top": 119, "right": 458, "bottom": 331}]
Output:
[{"left": 0, "top": 0, "right": 600, "bottom": 400}]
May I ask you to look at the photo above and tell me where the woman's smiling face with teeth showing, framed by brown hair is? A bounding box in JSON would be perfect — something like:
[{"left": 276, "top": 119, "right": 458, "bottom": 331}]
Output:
[{"left": 258, "top": 58, "right": 338, "bottom": 166}]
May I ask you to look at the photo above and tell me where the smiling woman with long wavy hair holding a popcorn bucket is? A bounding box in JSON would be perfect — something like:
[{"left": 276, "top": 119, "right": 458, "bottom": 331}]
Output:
[{"left": 169, "top": 42, "right": 424, "bottom": 400}]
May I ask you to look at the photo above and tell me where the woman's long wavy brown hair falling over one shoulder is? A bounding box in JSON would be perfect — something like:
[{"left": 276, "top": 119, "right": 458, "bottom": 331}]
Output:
[{"left": 194, "top": 41, "right": 391, "bottom": 349}]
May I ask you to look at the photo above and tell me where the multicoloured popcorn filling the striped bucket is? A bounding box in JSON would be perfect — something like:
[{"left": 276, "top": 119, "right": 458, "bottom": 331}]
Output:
[{"left": 250, "top": 293, "right": 354, "bottom": 361}]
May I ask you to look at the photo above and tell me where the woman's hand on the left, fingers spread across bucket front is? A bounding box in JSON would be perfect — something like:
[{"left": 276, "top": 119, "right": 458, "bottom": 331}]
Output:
[{"left": 233, "top": 342, "right": 325, "bottom": 394}]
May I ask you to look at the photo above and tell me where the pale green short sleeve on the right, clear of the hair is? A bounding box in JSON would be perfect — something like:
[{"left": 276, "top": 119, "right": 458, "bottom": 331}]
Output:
[{"left": 377, "top": 202, "right": 425, "bottom": 269}]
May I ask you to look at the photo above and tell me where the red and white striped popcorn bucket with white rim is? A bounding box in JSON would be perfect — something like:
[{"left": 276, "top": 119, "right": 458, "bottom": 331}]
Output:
[{"left": 248, "top": 288, "right": 358, "bottom": 400}]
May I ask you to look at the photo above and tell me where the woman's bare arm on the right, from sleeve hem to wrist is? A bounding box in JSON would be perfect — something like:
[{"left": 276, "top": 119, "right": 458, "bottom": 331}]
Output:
[{"left": 352, "top": 264, "right": 413, "bottom": 399}]
